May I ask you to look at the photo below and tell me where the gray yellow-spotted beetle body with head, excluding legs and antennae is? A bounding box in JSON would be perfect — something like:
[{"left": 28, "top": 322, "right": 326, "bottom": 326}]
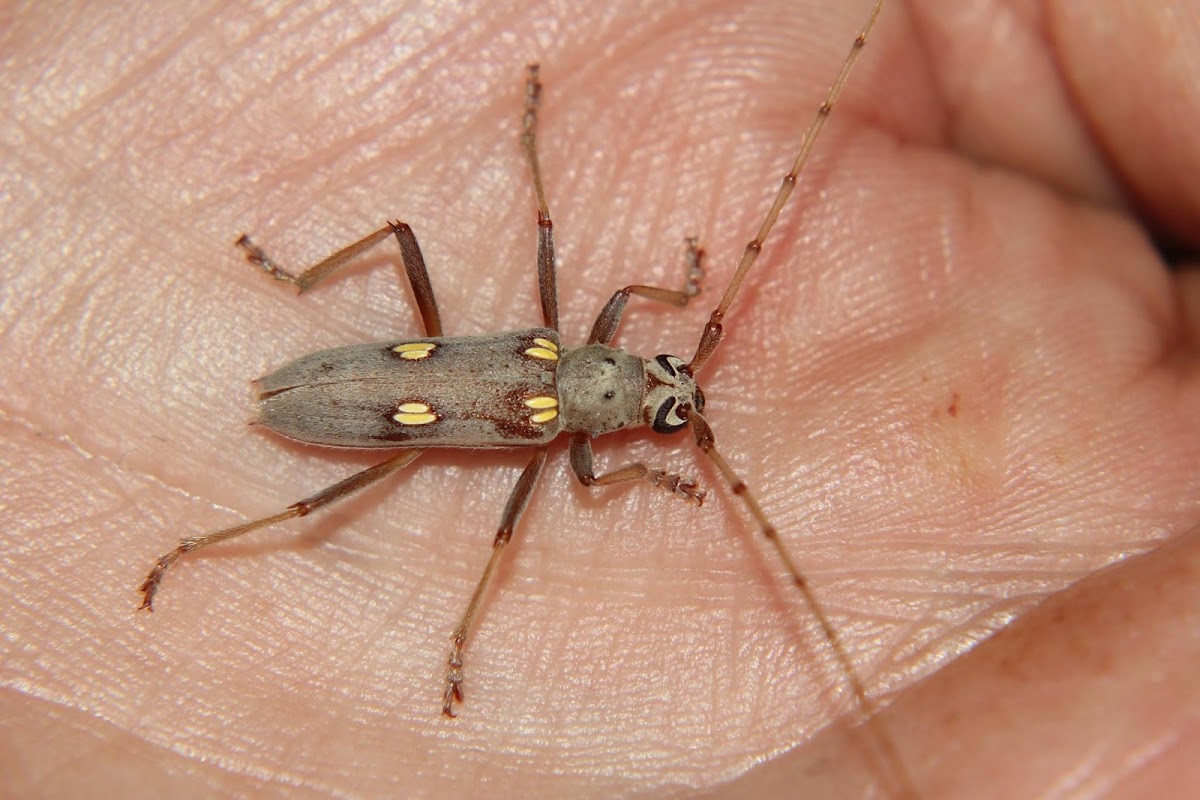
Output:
[{"left": 256, "top": 327, "right": 703, "bottom": 449}]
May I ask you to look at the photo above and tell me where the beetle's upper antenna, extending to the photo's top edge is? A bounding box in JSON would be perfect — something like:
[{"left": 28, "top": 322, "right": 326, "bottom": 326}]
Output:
[{"left": 688, "top": 0, "right": 883, "bottom": 374}]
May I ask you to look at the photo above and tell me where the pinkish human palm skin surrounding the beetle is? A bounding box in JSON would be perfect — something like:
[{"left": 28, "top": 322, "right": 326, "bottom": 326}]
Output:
[{"left": 0, "top": 0, "right": 1200, "bottom": 798}]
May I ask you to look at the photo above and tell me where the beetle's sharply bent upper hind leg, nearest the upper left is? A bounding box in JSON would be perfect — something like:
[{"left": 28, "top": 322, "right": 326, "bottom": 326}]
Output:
[{"left": 234, "top": 222, "right": 442, "bottom": 336}]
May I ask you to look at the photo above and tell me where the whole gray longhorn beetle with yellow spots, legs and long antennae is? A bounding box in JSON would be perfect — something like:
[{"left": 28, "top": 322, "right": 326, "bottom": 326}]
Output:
[{"left": 140, "top": 0, "right": 912, "bottom": 794}]
